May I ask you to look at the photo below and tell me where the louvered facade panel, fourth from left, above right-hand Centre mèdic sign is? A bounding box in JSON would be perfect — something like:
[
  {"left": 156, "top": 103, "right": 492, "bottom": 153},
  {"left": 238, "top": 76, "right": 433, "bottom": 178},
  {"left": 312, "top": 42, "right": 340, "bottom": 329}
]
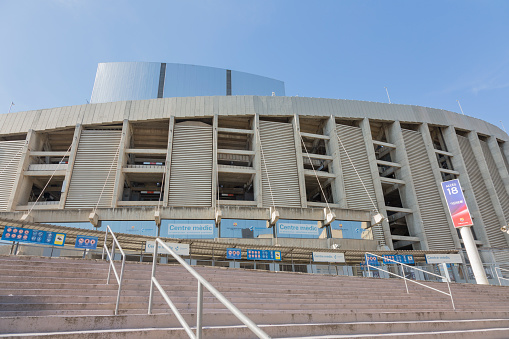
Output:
[{"left": 260, "top": 120, "right": 301, "bottom": 207}]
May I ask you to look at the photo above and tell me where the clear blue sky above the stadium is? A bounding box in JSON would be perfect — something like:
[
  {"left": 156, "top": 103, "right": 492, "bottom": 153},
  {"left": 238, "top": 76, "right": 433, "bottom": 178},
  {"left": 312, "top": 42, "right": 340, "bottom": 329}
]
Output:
[{"left": 0, "top": 0, "right": 509, "bottom": 131}]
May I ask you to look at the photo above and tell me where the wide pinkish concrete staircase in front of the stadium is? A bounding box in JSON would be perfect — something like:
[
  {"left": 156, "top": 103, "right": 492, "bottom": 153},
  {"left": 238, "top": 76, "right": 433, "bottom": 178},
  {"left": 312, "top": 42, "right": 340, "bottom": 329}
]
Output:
[{"left": 0, "top": 256, "right": 509, "bottom": 339}]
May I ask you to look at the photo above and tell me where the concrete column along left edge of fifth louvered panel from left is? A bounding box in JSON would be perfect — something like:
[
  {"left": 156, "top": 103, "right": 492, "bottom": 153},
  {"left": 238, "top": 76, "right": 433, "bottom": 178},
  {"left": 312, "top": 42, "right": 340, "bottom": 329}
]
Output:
[{"left": 324, "top": 115, "right": 348, "bottom": 208}]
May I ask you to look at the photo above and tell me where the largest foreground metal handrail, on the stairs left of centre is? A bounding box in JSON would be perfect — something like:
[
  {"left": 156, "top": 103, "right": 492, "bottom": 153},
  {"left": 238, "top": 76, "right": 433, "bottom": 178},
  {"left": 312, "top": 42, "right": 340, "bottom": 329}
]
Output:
[{"left": 148, "top": 238, "right": 271, "bottom": 339}]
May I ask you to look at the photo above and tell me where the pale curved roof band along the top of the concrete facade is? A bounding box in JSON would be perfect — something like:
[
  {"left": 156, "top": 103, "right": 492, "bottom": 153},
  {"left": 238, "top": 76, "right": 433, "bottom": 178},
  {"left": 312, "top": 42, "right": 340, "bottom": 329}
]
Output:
[{"left": 0, "top": 95, "right": 509, "bottom": 141}]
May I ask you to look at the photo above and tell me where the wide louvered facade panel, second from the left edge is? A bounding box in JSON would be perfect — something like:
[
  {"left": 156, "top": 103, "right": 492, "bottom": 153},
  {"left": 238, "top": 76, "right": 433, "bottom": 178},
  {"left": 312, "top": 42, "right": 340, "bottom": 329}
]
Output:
[{"left": 65, "top": 130, "right": 122, "bottom": 208}]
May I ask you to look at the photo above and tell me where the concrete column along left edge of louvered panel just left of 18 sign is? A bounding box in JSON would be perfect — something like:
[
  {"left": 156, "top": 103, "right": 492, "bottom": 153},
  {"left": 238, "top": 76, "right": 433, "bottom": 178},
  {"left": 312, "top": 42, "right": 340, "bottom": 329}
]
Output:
[{"left": 388, "top": 121, "right": 429, "bottom": 251}]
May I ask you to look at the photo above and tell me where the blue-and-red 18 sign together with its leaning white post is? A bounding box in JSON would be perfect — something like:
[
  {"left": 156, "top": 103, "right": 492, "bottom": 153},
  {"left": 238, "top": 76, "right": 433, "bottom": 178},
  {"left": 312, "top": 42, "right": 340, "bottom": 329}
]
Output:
[{"left": 442, "top": 179, "right": 489, "bottom": 285}]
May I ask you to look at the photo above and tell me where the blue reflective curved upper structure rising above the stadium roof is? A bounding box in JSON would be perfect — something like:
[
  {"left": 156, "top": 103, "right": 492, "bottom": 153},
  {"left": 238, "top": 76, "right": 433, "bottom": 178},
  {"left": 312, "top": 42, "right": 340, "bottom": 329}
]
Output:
[{"left": 90, "top": 62, "right": 285, "bottom": 103}]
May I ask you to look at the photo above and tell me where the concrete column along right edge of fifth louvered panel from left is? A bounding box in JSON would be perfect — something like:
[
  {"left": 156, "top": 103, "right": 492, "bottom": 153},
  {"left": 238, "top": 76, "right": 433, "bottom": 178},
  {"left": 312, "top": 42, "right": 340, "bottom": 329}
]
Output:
[{"left": 361, "top": 118, "right": 394, "bottom": 251}]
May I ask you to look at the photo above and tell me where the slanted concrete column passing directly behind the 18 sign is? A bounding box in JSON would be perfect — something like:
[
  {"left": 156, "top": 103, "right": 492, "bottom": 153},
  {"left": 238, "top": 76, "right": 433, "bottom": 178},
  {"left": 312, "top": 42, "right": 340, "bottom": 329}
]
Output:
[{"left": 442, "top": 125, "right": 490, "bottom": 247}]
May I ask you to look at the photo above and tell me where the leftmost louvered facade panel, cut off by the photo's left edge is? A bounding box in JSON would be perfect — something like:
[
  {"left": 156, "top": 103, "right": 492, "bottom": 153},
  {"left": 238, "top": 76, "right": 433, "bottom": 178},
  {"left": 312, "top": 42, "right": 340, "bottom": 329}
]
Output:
[{"left": 0, "top": 140, "right": 25, "bottom": 212}]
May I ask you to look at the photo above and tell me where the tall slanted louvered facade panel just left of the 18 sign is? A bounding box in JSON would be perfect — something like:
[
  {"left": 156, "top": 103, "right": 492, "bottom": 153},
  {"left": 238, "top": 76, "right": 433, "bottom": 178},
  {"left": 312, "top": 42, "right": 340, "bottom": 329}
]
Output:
[{"left": 403, "top": 129, "right": 455, "bottom": 250}]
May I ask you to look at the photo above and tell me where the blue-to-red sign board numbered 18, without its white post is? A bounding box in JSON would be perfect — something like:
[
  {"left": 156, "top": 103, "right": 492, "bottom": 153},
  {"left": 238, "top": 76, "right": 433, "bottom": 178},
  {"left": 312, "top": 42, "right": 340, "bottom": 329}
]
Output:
[{"left": 442, "top": 179, "right": 474, "bottom": 227}]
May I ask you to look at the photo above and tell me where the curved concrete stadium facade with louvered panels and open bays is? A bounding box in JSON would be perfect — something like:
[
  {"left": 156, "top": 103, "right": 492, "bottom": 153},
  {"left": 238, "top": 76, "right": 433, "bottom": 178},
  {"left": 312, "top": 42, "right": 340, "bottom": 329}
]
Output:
[{"left": 0, "top": 95, "right": 509, "bottom": 263}]
